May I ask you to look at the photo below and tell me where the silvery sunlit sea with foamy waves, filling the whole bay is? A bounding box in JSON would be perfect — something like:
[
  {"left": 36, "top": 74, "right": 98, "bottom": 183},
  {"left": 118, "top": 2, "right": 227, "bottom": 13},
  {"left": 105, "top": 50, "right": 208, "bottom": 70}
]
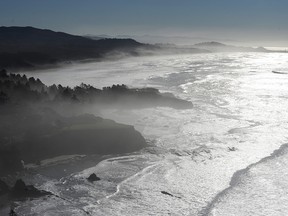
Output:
[{"left": 17, "top": 53, "right": 288, "bottom": 216}]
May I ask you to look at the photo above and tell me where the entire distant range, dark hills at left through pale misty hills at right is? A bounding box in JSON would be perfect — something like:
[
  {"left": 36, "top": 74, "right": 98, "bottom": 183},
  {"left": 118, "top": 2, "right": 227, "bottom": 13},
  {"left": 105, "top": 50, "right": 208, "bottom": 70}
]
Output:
[{"left": 0, "top": 26, "right": 268, "bottom": 70}]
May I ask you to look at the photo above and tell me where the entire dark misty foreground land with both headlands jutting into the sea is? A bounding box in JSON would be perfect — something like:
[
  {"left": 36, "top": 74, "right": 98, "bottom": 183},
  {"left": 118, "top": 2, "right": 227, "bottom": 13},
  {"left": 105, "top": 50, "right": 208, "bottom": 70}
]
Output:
[{"left": 0, "top": 70, "right": 192, "bottom": 175}]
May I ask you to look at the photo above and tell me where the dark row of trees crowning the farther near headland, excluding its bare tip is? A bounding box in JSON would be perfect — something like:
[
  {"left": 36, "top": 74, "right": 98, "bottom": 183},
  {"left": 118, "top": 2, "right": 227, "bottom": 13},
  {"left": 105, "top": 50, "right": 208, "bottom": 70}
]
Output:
[{"left": 0, "top": 69, "right": 164, "bottom": 104}]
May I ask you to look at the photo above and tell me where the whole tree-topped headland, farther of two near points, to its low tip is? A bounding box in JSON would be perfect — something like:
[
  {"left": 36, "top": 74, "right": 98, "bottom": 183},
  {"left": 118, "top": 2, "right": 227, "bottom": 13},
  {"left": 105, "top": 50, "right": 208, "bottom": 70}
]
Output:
[{"left": 0, "top": 69, "right": 193, "bottom": 109}]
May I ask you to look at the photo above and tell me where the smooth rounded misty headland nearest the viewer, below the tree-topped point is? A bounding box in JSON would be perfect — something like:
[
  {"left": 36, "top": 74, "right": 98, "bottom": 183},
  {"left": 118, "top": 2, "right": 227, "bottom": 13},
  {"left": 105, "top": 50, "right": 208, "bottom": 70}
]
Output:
[{"left": 0, "top": 109, "right": 146, "bottom": 177}]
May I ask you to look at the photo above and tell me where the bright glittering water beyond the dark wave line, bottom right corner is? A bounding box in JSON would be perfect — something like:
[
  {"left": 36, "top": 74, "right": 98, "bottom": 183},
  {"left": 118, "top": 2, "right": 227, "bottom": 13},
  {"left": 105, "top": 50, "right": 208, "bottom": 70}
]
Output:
[{"left": 207, "top": 145, "right": 288, "bottom": 216}]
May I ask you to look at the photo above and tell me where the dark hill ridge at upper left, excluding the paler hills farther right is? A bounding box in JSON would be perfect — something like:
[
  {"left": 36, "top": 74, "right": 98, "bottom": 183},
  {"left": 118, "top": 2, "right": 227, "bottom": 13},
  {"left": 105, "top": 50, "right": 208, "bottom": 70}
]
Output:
[{"left": 0, "top": 26, "right": 146, "bottom": 68}]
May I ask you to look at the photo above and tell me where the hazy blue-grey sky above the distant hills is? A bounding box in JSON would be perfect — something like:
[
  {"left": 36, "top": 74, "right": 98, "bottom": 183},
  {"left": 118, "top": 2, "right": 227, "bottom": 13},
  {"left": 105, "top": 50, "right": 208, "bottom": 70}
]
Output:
[{"left": 0, "top": 0, "right": 288, "bottom": 46}]
